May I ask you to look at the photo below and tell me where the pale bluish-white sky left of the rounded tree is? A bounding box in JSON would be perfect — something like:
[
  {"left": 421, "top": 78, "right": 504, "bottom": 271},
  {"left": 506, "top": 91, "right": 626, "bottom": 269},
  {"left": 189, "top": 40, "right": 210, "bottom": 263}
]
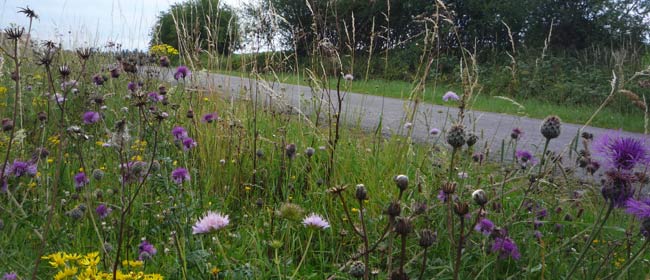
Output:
[{"left": 0, "top": 0, "right": 244, "bottom": 50}]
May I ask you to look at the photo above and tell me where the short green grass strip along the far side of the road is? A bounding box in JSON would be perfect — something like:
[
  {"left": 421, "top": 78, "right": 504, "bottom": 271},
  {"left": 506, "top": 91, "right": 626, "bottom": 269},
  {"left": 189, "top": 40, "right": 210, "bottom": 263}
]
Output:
[{"left": 211, "top": 71, "right": 644, "bottom": 133}]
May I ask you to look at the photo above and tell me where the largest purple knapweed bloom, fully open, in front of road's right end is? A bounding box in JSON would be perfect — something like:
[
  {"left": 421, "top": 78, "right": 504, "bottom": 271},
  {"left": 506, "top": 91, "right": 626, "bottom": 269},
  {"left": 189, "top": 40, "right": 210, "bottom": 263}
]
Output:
[{"left": 593, "top": 133, "right": 650, "bottom": 170}]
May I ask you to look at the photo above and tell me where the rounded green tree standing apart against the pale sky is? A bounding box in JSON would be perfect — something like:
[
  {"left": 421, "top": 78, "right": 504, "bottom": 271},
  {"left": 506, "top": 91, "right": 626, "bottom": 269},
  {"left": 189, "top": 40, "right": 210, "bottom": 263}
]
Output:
[{"left": 150, "top": 0, "right": 240, "bottom": 54}]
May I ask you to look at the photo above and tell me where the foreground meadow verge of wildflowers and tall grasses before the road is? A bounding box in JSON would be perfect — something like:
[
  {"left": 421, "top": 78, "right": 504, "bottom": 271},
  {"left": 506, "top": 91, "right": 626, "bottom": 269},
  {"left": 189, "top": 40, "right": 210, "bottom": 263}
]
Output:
[{"left": 0, "top": 5, "right": 650, "bottom": 280}]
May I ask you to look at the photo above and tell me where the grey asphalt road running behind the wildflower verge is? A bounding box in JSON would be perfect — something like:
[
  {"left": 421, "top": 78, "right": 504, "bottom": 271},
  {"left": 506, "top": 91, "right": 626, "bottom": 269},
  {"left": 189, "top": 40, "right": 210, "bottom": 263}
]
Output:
[{"left": 148, "top": 66, "right": 650, "bottom": 164}]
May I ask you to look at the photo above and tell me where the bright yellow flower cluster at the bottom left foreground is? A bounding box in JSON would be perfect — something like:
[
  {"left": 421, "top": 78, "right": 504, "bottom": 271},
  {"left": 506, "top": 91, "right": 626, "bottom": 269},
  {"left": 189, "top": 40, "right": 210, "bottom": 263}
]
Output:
[{"left": 43, "top": 252, "right": 163, "bottom": 280}]
